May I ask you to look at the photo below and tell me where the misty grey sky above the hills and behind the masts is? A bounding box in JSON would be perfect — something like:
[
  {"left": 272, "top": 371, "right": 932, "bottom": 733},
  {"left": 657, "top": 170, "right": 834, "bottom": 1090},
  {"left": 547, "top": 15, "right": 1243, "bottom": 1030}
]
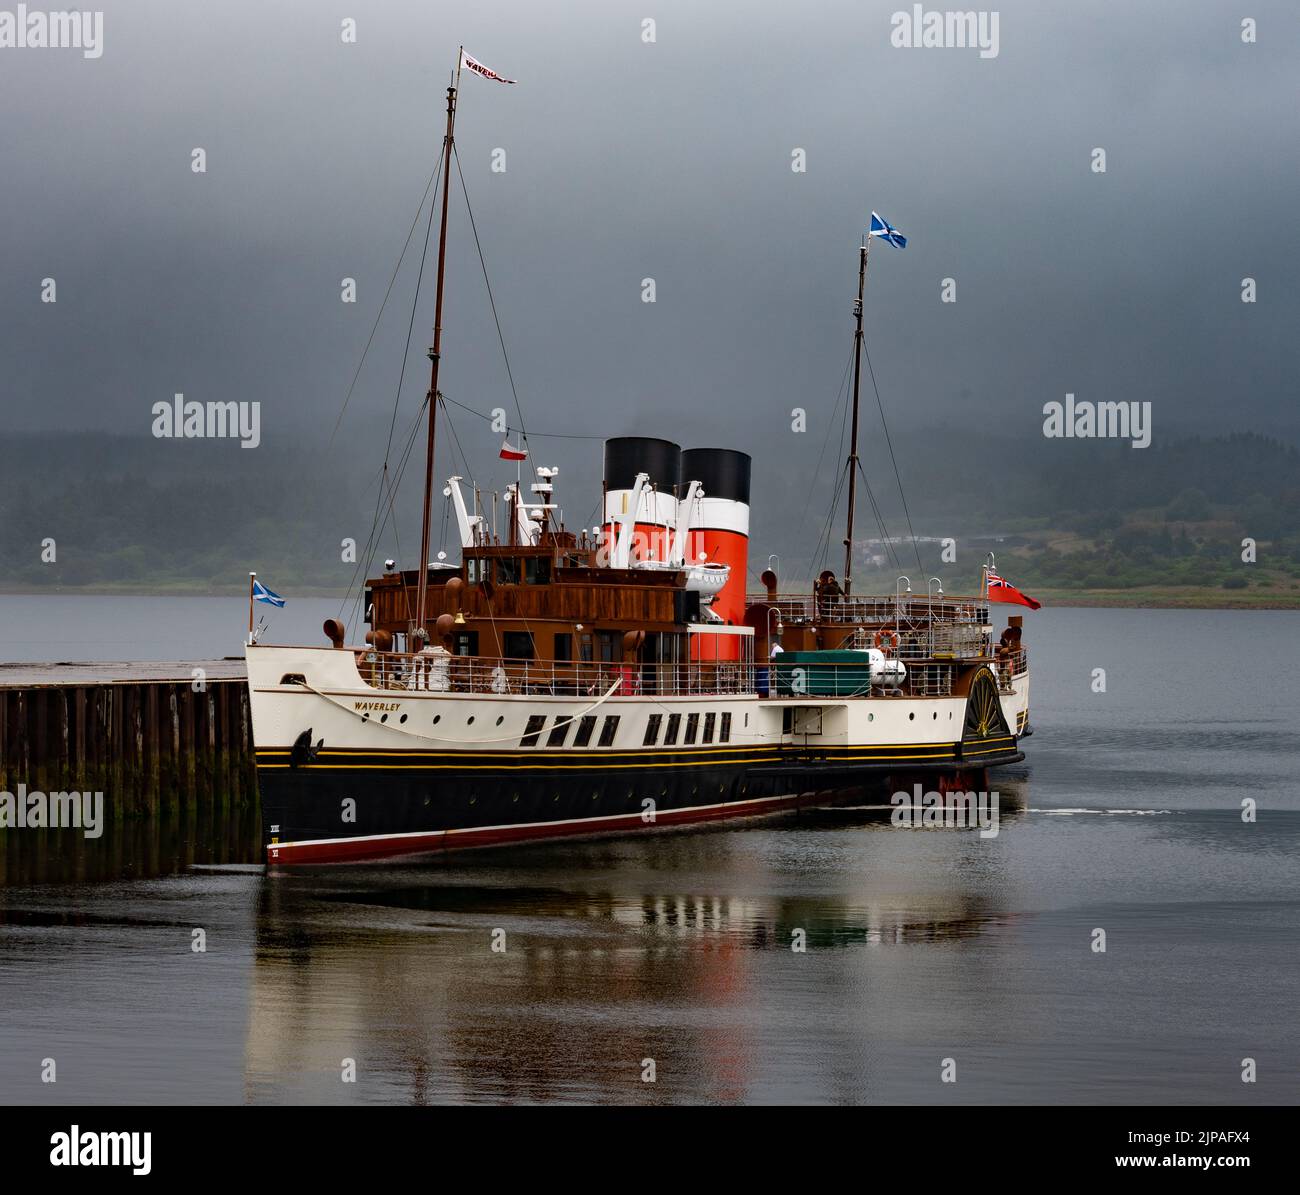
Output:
[{"left": 0, "top": 0, "right": 1300, "bottom": 497}]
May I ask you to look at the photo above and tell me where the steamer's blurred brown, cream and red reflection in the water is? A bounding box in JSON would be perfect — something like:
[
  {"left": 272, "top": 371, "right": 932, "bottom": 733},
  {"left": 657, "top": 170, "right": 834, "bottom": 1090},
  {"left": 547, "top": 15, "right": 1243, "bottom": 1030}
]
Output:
[{"left": 244, "top": 793, "right": 1021, "bottom": 1103}]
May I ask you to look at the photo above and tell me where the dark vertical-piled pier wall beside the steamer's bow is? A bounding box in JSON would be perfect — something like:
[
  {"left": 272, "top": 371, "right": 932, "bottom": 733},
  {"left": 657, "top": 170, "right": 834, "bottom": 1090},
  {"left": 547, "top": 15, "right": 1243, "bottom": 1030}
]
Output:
[{"left": 0, "top": 658, "right": 257, "bottom": 821}]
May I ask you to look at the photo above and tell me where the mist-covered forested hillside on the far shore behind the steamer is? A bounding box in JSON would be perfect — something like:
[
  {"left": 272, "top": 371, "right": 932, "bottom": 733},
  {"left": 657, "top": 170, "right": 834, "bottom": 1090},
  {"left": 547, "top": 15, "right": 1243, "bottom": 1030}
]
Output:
[{"left": 0, "top": 432, "right": 1300, "bottom": 593}]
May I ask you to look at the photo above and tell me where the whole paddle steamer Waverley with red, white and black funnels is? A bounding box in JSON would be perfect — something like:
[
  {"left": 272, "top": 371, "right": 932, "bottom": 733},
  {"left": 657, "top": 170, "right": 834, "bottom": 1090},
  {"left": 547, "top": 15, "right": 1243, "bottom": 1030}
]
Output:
[{"left": 246, "top": 58, "right": 1030, "bottom": 863}]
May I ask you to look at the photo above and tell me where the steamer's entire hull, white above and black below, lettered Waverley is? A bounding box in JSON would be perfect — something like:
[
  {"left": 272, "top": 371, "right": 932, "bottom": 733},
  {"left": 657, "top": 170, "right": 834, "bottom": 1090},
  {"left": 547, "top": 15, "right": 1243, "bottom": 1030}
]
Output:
[{"left": 250, "top": 649, "right": 1023, "bottom": 865}]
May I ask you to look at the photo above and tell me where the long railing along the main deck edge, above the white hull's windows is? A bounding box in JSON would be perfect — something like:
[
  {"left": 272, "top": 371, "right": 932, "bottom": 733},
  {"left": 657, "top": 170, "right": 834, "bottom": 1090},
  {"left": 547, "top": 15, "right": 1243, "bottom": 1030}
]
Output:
[{"left": 358, "top": 651, "right": 755, "bottom": 698}]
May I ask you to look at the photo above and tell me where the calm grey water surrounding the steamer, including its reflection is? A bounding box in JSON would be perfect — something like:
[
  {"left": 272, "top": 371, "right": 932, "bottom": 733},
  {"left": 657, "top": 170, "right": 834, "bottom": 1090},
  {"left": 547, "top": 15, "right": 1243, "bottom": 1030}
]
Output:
[{"left": 0, "top": 598, "right": 1300, "bottom": 1104}]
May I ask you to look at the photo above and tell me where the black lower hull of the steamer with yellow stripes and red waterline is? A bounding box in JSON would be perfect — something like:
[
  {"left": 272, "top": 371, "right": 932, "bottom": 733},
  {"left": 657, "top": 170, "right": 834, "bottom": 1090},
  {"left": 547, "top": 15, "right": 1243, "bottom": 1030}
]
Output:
[{"left": 259, "top": 736, "right": 1024, "bottom": 863}]
